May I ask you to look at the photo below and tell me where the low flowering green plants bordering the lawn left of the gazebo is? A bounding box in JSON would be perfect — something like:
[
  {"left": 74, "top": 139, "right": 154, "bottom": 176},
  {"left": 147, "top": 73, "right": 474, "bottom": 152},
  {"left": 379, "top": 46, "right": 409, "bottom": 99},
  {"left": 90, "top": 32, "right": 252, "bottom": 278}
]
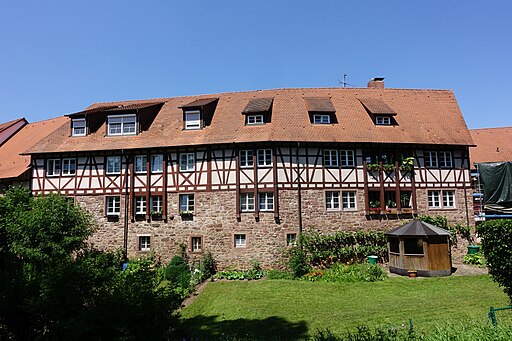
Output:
[{"left": 319, "top": 263, "right": 387, "bottom": 283}]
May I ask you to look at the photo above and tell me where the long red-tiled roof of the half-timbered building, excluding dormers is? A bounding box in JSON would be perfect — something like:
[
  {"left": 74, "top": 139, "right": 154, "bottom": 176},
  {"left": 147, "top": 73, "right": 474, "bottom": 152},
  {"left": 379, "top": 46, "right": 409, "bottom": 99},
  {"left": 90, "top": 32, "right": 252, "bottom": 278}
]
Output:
[{"left": 29, "top": 88, "right": 473, "bottom": 153}]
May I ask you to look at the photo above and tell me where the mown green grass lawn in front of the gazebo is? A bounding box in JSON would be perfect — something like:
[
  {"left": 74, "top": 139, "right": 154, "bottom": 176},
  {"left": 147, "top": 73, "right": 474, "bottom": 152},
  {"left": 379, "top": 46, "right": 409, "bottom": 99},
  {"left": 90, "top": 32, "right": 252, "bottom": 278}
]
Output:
[{"left": 179, "top": 275, "right": 510, "bottom": 339}]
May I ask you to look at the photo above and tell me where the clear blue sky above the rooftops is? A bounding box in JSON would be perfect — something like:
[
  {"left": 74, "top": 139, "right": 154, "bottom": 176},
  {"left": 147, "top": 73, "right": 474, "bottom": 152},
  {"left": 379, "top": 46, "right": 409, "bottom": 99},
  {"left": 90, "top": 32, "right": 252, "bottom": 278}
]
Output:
[{"left": 0, "top": 0, "right": 512, "bottom": 128}]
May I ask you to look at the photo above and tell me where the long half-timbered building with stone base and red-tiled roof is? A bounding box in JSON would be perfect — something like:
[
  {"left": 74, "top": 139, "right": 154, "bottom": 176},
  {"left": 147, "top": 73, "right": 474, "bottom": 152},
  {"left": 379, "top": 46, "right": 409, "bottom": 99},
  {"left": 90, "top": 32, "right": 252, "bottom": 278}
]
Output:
[{"left": 28, "top": 79, "right": 473, "bottom": 267}]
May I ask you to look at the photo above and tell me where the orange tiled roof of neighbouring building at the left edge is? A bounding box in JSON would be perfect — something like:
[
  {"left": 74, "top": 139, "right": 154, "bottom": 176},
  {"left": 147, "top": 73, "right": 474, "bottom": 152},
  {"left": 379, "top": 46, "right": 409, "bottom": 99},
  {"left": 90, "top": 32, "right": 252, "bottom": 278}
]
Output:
[{"left": 0, "top": 117, "right": 69, "bottom": 179}]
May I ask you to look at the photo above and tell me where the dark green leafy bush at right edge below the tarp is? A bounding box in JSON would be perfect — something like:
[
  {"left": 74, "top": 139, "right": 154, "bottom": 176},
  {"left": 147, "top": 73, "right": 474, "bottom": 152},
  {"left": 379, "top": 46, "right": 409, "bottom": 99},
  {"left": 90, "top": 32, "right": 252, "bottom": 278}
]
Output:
[{"left": 477, "top": 219, "right": 512, "bottom": 303}]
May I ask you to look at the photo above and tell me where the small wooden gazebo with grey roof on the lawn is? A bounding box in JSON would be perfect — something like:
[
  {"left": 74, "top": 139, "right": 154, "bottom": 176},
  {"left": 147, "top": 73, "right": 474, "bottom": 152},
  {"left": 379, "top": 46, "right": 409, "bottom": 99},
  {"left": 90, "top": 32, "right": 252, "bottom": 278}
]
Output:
[{"left": 386, "top": 220, "right": 452, "bottom": 277}]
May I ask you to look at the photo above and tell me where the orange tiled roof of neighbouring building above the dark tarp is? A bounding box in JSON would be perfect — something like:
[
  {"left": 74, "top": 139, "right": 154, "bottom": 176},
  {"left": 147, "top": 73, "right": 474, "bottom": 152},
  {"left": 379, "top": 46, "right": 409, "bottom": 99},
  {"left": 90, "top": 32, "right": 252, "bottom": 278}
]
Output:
[{"left": 469, "top": 127, "right": 512, "bottom": 168}]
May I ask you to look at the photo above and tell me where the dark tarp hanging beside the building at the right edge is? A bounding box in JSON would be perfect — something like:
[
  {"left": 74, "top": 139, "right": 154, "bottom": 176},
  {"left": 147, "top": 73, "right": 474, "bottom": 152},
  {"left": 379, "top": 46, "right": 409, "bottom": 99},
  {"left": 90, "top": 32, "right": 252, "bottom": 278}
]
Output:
[{"left": 477, "top": 162, "right": 512, "bottom": 206}]
